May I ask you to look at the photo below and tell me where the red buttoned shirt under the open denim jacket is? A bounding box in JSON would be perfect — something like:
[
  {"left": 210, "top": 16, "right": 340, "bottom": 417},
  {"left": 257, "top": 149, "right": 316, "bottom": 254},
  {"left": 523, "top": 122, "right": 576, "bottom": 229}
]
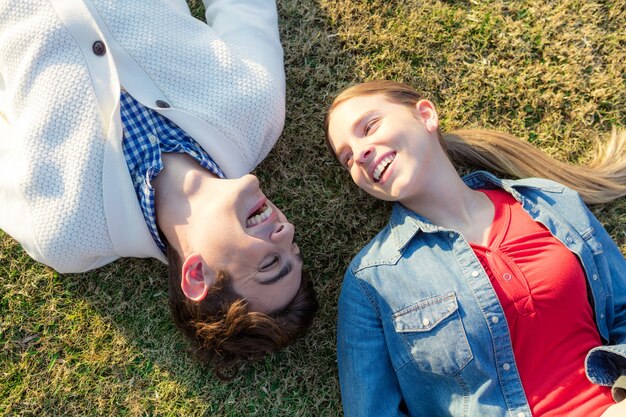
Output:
[{"left": 471, "top": 190, "right": 614, "bottom": 417}]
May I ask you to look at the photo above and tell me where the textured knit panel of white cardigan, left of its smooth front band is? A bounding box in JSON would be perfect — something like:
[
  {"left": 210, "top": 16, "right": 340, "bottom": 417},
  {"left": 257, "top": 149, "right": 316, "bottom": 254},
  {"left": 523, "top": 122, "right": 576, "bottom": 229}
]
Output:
[{"left": 0, "top": 1, "right": 114, "bottom": 271}]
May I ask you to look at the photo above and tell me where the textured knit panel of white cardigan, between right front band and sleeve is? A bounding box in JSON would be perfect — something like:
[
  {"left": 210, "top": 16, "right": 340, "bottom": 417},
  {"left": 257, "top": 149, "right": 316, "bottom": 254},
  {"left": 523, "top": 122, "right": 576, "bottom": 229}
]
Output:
[{"left": 92, "top": 0, "right": 283, "bottom": 169}]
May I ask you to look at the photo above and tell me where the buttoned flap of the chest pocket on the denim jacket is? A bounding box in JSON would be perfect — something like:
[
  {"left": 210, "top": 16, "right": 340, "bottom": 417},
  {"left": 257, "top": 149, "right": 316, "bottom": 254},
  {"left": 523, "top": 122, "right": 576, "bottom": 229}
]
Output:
[{"left": 393, "top": 292, "right": 459, "bottom": 333}]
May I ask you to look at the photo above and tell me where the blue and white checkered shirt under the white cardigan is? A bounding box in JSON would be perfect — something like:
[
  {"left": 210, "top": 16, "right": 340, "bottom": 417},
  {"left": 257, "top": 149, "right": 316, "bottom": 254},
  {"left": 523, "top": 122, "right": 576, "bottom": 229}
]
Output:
[{"left": 120, "top": 91, "right": 225, "bottom": 253}]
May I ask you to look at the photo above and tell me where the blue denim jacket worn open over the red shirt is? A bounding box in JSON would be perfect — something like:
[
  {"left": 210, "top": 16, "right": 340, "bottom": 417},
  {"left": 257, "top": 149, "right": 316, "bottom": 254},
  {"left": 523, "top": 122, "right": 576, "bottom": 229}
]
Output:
[{"left": 337, "top": 171, "right": 626, "bottom": 417}]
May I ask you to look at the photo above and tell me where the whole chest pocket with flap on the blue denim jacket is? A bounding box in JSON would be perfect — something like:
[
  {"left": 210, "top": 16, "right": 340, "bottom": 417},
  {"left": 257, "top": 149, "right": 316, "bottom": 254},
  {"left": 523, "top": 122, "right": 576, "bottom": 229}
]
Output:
[{"left": 392, "top": 292, "right": 473, "bottom": 375}]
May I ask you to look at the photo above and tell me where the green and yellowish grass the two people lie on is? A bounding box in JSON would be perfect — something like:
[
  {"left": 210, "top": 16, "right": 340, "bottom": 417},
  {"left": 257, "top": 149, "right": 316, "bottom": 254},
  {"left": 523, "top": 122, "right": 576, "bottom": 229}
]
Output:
[{"left": 0, "top": 0, "right": 626, "bottom": 417}]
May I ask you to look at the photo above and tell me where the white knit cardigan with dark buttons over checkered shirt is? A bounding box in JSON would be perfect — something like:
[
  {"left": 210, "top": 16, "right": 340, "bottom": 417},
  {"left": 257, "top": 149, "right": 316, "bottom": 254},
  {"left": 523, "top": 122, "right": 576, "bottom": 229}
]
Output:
[{"left": 0, "top": 0, "right": 285, "bottom": 272}]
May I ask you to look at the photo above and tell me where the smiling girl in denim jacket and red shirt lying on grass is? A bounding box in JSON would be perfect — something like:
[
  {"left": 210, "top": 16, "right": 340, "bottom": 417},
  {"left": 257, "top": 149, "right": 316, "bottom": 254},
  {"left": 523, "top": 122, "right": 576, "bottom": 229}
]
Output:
[{"left": 326, "top": 81, "right": 626, "bottom": 417}]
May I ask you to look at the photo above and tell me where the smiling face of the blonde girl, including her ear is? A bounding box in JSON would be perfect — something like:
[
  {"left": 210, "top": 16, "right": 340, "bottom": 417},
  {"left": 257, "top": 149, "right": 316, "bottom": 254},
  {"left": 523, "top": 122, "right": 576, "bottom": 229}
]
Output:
[{"left": 328, "top": 94, "right": 438, "bottom": 202}]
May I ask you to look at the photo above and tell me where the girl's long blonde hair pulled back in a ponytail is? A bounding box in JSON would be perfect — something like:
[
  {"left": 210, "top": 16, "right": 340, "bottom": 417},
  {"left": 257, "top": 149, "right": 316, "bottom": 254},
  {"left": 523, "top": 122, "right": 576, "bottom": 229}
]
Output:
[{"left": 324, "top": 80, "right": 626, "bottom": 204}]
